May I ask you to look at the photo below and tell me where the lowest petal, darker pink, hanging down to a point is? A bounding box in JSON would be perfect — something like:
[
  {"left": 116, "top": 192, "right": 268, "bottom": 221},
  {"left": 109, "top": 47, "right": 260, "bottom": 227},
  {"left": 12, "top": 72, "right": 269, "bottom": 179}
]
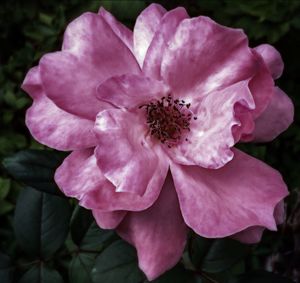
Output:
[{"left": 117, "top": 176, "right": 187, "bottom": 280}]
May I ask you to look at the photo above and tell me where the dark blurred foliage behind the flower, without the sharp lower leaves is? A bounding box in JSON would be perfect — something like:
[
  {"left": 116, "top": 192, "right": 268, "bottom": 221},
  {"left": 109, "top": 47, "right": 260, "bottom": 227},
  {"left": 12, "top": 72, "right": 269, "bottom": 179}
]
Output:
[{"left": 0, "top": 0, "right": 300, "bottom": 283}]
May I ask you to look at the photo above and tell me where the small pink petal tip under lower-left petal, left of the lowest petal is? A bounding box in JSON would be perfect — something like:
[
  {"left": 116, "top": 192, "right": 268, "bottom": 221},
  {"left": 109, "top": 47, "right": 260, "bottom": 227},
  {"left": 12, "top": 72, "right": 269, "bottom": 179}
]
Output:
[{"left": 93, "top": 209, "right": 127, "bottom": 229}]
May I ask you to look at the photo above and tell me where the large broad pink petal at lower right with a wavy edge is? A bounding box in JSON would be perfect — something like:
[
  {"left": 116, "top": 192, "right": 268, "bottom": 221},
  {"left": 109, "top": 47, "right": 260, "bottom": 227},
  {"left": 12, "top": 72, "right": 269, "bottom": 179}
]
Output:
[{"left": 171, "top": 150, "right": 288, "bottom": 238}]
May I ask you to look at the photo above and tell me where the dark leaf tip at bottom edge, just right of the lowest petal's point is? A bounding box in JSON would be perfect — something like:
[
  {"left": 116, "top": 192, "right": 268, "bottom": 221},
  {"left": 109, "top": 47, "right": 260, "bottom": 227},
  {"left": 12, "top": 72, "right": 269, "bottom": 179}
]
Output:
[{"left": 146, "top": 265, "right": 201, "bottom": 283}]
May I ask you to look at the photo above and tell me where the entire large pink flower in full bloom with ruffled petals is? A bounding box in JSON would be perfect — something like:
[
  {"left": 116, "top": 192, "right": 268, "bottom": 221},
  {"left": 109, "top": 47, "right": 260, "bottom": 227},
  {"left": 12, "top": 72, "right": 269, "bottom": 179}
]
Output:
[{"left": 22, "top": 4, "right": 293, "bottom": 280}]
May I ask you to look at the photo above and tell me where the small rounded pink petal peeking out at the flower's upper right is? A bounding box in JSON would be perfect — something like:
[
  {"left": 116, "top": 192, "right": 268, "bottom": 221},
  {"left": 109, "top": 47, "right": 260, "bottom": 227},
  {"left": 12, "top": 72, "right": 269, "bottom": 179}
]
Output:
[{"left": 254, "top": 44, "right": 284, "bottom": 79}]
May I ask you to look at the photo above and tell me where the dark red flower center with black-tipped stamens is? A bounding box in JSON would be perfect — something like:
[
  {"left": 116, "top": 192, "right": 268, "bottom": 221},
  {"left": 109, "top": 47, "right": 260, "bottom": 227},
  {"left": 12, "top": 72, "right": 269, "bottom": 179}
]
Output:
[{"left": 139, "top": 94, "right": 197, "bottom": 148}]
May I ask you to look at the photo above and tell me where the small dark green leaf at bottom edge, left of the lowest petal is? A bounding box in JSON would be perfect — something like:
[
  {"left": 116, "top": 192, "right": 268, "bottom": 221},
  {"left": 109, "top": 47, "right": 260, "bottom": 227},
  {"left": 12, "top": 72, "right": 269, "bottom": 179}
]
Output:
[{"left": 69, "top": 253, "right": 97, "bottom": 283}]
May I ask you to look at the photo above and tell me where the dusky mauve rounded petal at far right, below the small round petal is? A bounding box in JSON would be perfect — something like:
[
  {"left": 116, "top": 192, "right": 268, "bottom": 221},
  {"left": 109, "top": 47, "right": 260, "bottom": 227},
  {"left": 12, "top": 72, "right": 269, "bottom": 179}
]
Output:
[{"left": 252, "top": 87, "right": 294, "bottom": 142}]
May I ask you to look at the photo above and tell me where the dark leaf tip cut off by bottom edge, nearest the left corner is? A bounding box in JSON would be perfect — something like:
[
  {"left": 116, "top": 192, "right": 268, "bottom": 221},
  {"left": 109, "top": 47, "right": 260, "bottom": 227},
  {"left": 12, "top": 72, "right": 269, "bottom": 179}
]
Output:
[{"left": 18, "top": 263, "right": 64, "bottom": 283}]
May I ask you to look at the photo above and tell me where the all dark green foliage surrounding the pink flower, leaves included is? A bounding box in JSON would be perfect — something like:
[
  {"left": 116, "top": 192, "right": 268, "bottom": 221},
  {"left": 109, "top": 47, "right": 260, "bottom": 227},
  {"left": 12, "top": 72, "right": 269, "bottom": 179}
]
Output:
[{"left": 0, "top": 0, "right": 300, "bottom": 283}]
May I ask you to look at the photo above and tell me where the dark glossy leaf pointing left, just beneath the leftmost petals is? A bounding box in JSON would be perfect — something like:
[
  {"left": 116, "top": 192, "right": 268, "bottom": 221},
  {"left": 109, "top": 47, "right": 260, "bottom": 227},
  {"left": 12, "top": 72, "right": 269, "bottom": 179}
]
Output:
[{"left": 3, "top": 149, "right": 65, "bottom": 195}]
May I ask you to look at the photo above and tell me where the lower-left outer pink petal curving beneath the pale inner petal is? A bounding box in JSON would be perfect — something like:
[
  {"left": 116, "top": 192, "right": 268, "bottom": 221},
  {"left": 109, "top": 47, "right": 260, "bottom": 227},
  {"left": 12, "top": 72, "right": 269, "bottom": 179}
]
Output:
[{"left": 55, "top": 149, "right": 168, "bottom": 212}]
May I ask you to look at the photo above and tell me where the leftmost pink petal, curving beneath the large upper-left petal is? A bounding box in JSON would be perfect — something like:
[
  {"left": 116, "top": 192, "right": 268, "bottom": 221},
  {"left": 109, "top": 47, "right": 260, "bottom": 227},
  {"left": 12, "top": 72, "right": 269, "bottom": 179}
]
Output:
[{"left": 22, "top": 67, "right": 96, "bottom": 150}]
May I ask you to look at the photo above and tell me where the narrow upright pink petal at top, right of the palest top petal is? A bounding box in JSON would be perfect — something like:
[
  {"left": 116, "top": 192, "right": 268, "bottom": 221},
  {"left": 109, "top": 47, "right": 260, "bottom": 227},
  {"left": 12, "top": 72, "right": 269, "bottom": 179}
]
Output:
[{"left": 143, "top": 7, "right": 189, "bottom": 79}]
